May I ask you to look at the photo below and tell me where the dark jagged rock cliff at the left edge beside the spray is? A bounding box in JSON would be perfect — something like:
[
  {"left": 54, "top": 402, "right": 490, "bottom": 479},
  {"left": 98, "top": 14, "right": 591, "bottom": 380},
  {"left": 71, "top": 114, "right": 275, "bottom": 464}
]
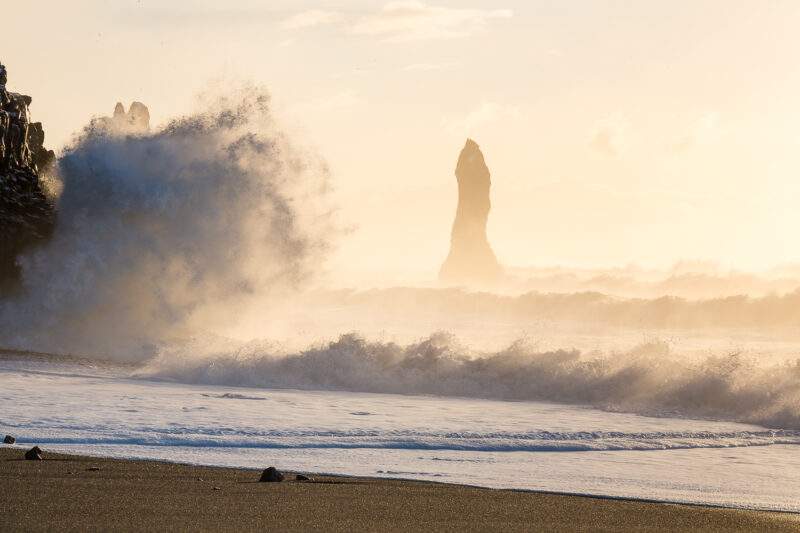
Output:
[{"left": 0, "top": 64, "right": 55, "bottom": 294}]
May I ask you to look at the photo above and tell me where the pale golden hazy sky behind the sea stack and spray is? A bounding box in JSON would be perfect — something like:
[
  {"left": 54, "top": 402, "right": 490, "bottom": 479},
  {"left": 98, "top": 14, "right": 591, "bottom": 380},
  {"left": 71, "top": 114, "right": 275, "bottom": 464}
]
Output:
[{"left": 6, "top": 0, "right": 800, "bottom": 279}]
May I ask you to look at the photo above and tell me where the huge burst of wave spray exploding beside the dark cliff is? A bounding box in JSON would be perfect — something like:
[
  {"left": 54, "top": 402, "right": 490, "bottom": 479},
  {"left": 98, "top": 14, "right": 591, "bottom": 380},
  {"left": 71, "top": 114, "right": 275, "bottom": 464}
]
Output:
[{"left": 0, "top": 89, "right": 330, "bottom": 360}]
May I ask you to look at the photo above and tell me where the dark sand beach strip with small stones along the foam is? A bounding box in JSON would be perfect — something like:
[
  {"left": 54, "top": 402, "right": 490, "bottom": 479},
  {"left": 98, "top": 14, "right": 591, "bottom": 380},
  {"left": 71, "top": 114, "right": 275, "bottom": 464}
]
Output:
[{"left": 0, "top": 446, "right": 800, "bottom": 532}]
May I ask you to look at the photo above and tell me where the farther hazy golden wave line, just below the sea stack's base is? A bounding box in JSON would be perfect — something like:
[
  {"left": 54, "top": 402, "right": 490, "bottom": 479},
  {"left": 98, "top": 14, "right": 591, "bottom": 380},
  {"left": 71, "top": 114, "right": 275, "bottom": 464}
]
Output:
[{"left": 315, "top": 287, "right": 800, "bottom": 328}]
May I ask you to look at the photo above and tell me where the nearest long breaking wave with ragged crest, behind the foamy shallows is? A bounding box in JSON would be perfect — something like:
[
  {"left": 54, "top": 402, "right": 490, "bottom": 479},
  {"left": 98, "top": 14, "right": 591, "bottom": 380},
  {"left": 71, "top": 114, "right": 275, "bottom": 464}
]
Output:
[{"left": 138, "top": 333, "right": 800, "bottom": 430}]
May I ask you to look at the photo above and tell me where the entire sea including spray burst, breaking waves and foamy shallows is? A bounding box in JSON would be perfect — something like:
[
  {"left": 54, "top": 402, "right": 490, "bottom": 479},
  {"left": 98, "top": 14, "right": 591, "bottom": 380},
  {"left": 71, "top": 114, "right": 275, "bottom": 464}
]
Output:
[{"left": 0, "top": 88, "right": 800, "bottom": 512}]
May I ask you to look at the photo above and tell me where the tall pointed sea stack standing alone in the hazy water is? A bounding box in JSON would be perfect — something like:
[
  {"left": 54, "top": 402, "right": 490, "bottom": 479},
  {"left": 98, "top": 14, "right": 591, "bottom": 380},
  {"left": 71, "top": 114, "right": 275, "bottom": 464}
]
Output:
[{"left": 439, "top": 139, "right": 503, "bottom": 288}]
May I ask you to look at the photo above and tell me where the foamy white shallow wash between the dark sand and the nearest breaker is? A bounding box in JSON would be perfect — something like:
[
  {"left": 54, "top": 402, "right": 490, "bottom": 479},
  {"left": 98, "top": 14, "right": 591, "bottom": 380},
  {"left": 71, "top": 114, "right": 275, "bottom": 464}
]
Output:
[{"left": 0, "top": 355, "right": 800, "bottom": 512}]
